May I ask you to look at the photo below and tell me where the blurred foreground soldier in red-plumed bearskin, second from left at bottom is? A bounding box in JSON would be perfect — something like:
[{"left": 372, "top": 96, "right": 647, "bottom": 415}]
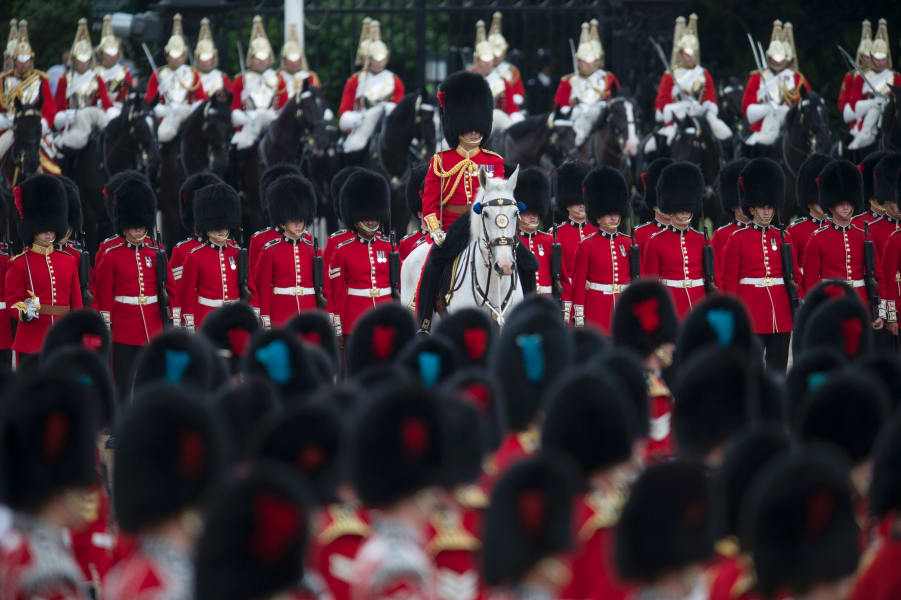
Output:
[{"left": 103, "top": 384, "right": 225, "bottom": 598}]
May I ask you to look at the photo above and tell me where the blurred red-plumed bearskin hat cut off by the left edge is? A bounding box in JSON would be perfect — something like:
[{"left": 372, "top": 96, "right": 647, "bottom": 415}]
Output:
[{"left": 0, "top": 369, "right": 98, "bottom": 512}]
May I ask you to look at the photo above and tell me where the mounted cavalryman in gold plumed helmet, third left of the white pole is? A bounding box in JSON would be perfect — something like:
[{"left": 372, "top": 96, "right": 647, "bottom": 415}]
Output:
[{"left": 144, "top": 13, "right": 206, "bottom": 144}]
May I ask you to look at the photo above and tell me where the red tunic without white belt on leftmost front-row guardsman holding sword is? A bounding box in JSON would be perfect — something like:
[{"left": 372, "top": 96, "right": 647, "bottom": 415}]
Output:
[{"left": 4, "top": 246, "right": 82, "bottom": 354}]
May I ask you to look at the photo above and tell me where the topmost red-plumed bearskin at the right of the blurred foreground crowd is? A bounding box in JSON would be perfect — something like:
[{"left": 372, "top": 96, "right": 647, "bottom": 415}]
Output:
[{"left": 801, "top": 297, "right": 873, "bottom": 360}]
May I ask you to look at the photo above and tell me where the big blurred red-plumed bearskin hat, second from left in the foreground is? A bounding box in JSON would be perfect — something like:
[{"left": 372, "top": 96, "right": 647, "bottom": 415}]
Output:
[{"left": 113, "top": 383, "right": 225, "bottom": 534}]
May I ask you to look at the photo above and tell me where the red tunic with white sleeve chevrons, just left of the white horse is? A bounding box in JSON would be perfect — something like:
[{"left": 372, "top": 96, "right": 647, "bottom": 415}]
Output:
[{"left": 328, "top": 234, "right": 392, "bottom": 335}]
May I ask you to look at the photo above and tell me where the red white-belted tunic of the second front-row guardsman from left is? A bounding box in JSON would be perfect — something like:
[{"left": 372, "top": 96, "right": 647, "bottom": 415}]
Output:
[{"left": 96, "top": 241, "right": 175, "bottom": 346}]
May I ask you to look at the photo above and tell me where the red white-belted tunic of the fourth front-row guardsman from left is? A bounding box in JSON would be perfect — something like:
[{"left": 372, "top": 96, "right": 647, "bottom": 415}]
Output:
[{"left": 253, "top": 237, "right": 317, "bottom": 327}]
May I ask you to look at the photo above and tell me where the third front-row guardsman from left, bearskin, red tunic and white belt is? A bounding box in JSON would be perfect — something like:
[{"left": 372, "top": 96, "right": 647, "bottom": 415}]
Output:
[{"left": 178, "top": 183, "right": 241, "bottom": 331}]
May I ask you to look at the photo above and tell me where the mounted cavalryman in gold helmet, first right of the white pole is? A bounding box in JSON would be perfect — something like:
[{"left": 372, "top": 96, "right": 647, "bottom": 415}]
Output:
[{"left": 338, "top": 21, "right": 404, "bottom": 153}]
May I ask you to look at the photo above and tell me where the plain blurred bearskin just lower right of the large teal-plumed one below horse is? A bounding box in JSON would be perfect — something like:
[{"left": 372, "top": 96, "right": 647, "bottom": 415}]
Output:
[{"left": 541, "top": 368, "right": 641, "bottom": 481}]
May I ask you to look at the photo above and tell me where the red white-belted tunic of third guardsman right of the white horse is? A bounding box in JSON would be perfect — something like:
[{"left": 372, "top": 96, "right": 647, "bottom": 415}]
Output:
[{"left": 572, "top": 231, "right": 632, "bottom": 335}]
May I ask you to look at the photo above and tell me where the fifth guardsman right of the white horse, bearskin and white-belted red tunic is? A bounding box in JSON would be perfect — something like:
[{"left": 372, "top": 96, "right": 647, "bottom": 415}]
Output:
[{"left": 641, "top": 162, "right": 707, "bottom": 318}]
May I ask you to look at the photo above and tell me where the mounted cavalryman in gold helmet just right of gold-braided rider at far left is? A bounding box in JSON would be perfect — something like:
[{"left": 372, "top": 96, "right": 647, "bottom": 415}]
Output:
[{"left": 53, "top": 18, "right": 119, "bottom": 150}]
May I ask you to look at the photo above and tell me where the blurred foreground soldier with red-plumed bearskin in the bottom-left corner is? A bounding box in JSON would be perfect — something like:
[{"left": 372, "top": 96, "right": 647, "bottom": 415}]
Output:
[{"left": 0, "top": 371, "right": 97, "bottom": 600}]
